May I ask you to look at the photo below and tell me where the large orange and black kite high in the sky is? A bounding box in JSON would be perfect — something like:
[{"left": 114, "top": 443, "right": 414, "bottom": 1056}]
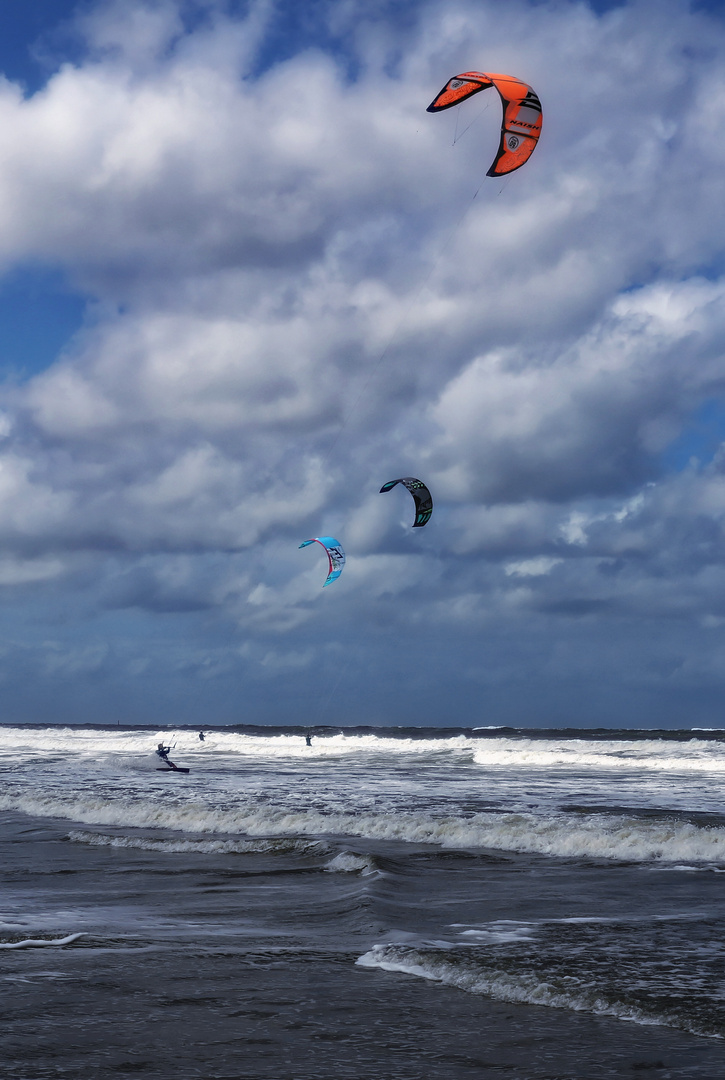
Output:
[{"left": 428, "top": 71, "right": 541, "bottom": 176}]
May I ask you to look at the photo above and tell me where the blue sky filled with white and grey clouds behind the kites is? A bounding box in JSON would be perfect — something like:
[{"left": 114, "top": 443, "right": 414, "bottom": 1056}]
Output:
[{"left": 0, "top": 0, "right": 725, "bottom": 728}]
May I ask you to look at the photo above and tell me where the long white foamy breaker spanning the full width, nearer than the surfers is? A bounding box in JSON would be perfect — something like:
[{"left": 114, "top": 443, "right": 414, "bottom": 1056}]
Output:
[{"left": 0, "top": 794, "right": 725, "bottom": 865}]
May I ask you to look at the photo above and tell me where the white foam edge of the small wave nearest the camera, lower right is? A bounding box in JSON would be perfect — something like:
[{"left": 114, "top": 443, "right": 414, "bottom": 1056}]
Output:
[{"left": 357, "top": 944, "right": 721, "bottom": 1038}]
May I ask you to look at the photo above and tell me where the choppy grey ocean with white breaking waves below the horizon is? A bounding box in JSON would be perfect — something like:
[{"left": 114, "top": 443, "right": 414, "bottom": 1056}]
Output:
[{"left": 0, "top": 725, "right": 725, "bottom": 1080}]
